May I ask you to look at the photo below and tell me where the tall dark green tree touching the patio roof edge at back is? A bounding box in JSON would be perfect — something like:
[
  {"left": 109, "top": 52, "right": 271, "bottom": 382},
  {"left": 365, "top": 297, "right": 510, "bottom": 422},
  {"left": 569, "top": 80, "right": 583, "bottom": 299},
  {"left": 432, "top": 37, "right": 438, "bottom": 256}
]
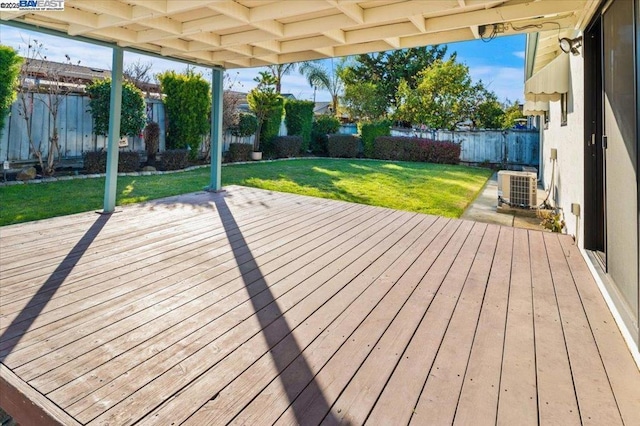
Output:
[{"left": 342, "top": 45, "right": 455, "bottom": 110}]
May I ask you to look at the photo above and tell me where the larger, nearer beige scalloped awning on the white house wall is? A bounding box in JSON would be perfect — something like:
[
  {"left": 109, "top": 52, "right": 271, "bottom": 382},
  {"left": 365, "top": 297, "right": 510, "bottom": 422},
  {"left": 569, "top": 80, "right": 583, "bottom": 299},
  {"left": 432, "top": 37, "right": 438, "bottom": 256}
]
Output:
[{"left": 524, "top": 53, "right": 569, "bottom": 102}]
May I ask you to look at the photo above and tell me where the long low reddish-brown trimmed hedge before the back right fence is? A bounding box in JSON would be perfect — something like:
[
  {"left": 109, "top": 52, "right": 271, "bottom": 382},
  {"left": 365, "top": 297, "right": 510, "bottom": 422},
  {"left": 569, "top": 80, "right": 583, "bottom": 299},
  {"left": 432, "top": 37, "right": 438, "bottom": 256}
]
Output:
[{"left": 373, "top": 136, "right": 460, "bottom": 164}]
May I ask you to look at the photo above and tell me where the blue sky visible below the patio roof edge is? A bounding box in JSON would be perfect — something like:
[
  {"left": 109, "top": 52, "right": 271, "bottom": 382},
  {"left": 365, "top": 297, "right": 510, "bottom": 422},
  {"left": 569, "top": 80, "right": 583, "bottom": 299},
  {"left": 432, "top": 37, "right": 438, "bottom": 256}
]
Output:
[{"left": 0, "top": 25, "right": 525, "bottom": 102}]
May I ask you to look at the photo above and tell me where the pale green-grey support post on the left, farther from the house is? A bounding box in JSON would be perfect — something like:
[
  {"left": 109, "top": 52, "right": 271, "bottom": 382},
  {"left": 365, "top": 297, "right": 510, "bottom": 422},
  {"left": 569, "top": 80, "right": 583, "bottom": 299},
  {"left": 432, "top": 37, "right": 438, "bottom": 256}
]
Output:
[{"left": 103, "top": 46, "right": 123, "bottom": 213}]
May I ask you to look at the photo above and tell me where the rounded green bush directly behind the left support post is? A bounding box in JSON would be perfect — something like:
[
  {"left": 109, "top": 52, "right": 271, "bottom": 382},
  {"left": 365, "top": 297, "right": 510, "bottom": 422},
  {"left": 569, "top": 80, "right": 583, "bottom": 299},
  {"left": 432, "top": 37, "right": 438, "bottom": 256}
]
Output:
[{"left": 86, "top": 78, "right": 147, "bottom": 137}]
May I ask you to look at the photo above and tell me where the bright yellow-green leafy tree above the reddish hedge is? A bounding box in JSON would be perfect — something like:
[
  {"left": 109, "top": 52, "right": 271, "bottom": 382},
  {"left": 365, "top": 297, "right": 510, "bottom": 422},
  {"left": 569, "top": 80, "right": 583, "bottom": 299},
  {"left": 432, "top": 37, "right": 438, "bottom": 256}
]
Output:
[{"left": 396, "top": 58, "right": 478, "bottom": 130}]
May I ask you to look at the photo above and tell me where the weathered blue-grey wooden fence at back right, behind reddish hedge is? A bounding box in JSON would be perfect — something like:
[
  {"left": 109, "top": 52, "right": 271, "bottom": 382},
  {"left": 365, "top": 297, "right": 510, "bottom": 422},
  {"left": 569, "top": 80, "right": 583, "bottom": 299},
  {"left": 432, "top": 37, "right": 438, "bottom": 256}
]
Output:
[{"left": 391, "top": 129, "right": 540, "bottom": 166}]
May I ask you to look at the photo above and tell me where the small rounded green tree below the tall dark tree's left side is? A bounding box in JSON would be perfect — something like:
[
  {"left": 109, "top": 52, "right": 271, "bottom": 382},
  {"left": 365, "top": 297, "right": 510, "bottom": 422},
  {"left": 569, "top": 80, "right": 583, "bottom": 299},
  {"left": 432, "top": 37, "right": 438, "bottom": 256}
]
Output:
[{"left": 342, "top": 81, "right": 386, "bottom": 121}]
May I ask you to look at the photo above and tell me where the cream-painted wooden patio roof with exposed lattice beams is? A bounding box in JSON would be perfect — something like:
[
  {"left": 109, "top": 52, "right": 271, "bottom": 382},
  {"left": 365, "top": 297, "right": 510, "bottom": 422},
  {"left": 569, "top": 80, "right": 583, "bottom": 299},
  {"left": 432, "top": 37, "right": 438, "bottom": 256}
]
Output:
[{"left": 0, "top": 0, "right": 599, "bottom": 68}]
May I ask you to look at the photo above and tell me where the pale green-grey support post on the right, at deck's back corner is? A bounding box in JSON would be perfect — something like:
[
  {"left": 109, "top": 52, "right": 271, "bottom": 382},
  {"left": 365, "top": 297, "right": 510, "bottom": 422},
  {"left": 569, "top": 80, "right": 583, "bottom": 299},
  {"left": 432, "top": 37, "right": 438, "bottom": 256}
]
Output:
[{"left": 207, "top": 68, "right": 224, "bottom": 191}]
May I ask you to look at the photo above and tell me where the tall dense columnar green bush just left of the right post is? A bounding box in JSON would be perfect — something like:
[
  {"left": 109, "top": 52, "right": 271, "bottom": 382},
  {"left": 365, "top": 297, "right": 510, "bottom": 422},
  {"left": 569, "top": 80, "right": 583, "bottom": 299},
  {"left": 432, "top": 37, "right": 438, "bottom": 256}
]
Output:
[{"left": 158, "top": 71, "right": 211, "bottom": 158}]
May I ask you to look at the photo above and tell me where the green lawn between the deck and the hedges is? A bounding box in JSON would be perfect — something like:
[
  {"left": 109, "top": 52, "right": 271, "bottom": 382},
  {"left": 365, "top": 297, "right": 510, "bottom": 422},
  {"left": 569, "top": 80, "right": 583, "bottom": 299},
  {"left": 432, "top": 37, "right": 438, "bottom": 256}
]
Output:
[{"left": 0, "top": 159, "right": 492, "bottom": 225}]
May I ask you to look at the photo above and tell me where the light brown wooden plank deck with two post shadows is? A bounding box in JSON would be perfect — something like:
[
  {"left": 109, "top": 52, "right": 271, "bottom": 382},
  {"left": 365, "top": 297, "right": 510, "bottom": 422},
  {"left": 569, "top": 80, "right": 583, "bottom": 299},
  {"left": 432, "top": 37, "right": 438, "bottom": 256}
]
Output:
[{"left": 0, "top": 187, "right": 640, "bottom": 426}]
